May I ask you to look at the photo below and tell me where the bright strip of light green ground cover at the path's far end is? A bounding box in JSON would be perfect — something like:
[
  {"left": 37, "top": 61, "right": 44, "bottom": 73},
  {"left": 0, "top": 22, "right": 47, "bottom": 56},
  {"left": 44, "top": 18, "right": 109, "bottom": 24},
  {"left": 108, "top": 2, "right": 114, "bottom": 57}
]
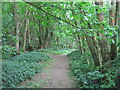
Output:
[{"left": 37, "top": 49, "right": 75, "bottom": 55}]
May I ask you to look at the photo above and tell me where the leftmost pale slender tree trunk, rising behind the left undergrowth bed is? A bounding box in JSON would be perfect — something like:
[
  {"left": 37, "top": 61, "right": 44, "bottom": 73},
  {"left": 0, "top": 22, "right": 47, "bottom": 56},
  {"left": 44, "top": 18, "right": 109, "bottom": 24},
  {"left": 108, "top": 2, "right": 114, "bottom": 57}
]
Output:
[{"left": 13, "top": 3, "right": 20, "bottom": 51}]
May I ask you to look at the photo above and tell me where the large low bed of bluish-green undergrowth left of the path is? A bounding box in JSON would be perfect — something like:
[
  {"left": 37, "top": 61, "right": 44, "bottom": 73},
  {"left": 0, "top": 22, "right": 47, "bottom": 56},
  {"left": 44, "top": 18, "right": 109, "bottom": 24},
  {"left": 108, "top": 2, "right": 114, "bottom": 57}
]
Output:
[{"left": 2, "top": 52, "right": 51, "bottom": 88}]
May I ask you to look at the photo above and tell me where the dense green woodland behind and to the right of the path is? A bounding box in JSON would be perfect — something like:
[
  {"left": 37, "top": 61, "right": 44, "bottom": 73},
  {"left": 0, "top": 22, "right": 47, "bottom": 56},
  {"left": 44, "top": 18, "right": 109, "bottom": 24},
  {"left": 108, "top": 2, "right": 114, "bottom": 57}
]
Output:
[{"left": 2, "top": 0, "right": 120, "bottom": 88}]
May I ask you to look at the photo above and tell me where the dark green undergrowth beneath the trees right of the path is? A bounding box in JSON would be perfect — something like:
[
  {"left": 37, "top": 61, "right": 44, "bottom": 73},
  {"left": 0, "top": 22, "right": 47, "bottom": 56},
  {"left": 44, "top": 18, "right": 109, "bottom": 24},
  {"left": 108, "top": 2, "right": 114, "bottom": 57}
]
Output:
[{"left": 68, "top": 51, "right": 120, "bottom": 88}]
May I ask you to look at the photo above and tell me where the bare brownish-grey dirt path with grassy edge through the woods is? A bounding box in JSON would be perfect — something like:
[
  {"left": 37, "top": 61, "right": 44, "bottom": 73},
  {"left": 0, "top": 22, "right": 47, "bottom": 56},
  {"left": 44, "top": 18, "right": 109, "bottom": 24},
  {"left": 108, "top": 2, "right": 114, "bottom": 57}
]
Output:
[{"left": 17, "top": 54, "right": 75, "bottom": 88}]
